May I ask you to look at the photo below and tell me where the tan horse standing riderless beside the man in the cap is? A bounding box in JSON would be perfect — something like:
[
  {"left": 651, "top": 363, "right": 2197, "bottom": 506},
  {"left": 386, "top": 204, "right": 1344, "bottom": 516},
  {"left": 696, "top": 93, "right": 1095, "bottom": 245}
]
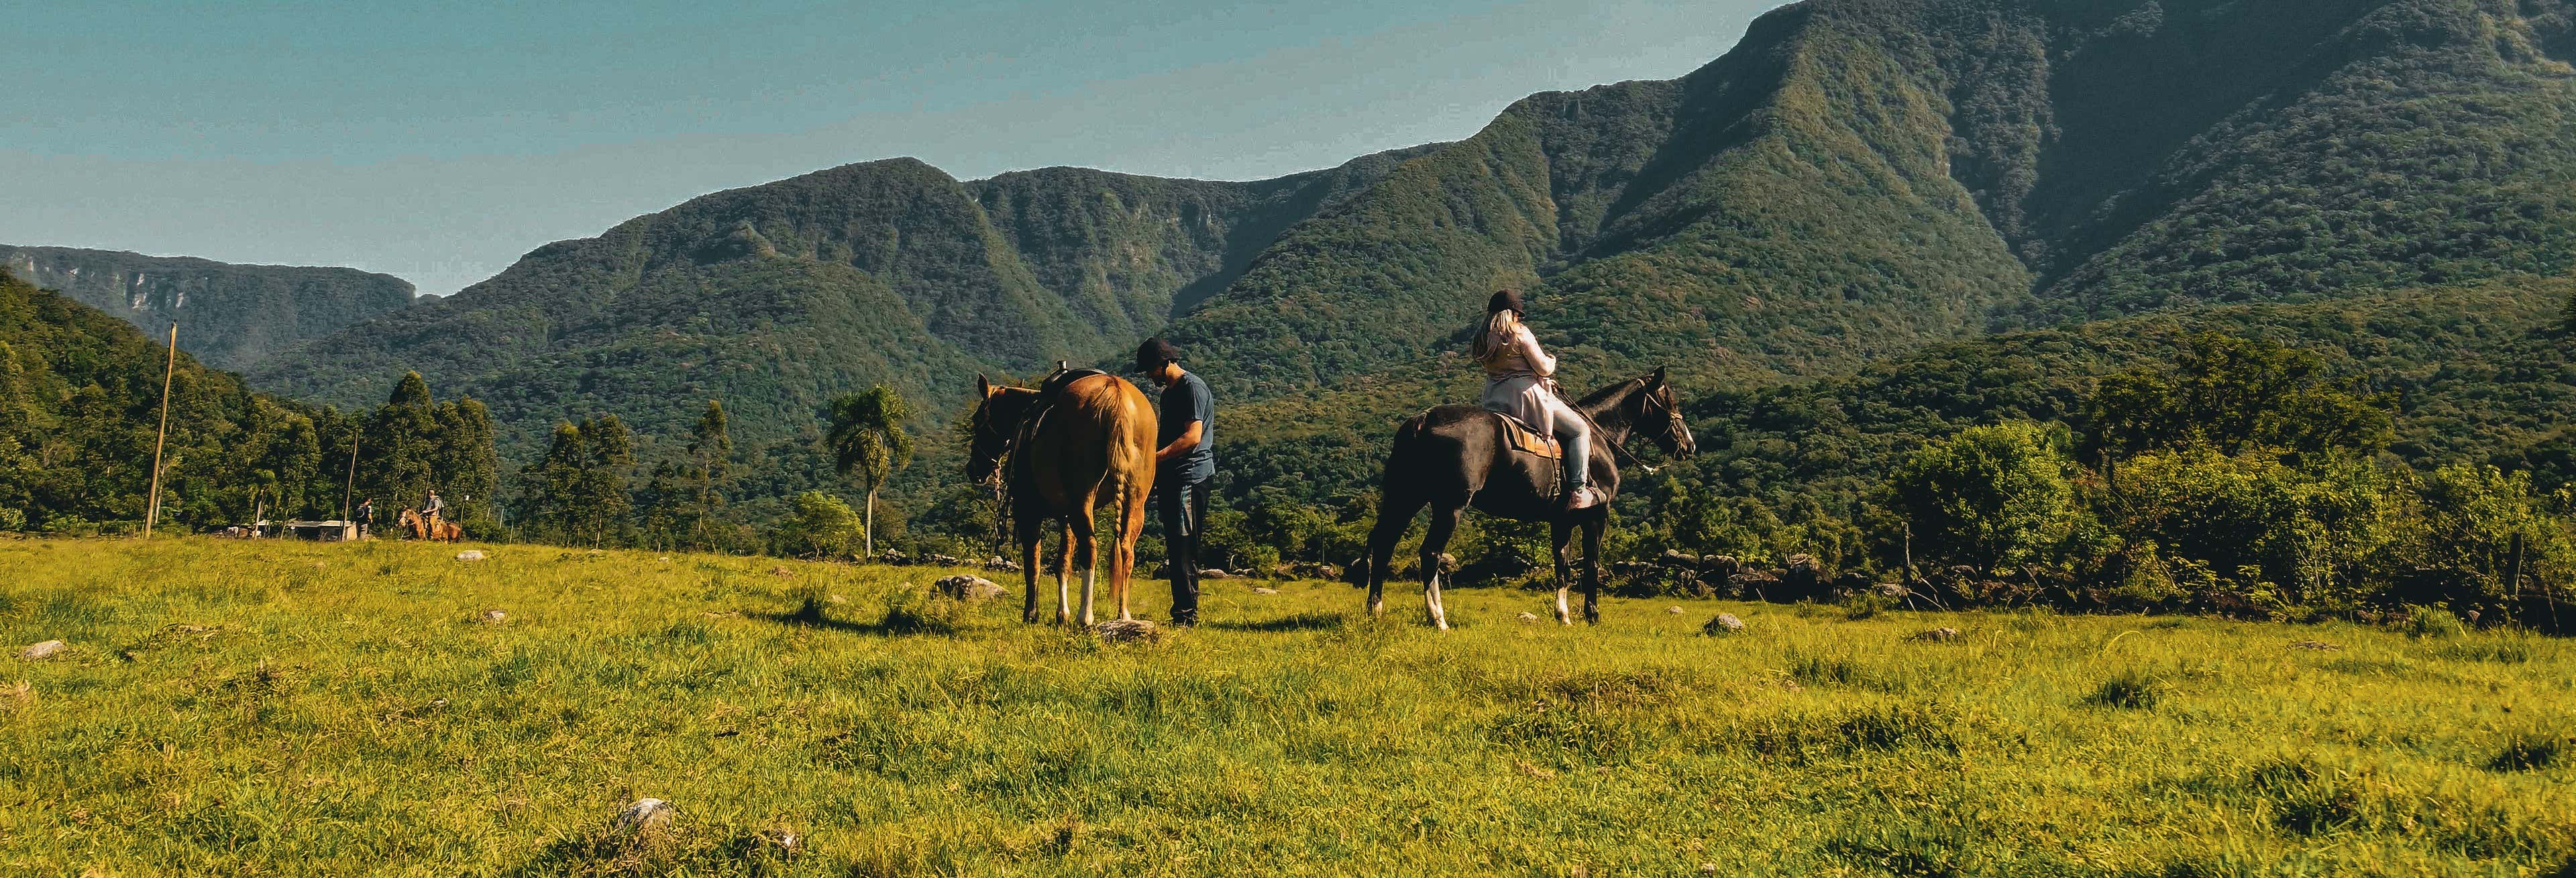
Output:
[{"left": 966, "top": 374, "right": 1154, "bottom": 626}]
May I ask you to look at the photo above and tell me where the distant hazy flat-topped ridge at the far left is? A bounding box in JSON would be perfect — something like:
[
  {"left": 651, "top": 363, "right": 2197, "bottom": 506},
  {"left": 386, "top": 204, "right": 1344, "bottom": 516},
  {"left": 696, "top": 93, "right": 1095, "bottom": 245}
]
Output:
[{"left": 0, "top": 245, "right": 412, "bottom": 371}]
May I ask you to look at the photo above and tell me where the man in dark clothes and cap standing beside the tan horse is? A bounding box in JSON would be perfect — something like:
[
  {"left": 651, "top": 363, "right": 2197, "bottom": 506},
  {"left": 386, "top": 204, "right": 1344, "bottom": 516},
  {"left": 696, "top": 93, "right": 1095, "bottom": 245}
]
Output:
[{"left": 1136, "top": 337, "right": 1216, "bottom": 626}]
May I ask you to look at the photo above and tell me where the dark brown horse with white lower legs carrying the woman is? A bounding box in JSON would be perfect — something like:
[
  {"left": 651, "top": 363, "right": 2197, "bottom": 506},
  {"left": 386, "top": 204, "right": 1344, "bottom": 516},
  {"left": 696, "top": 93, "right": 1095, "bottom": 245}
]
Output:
[{"left": 1368, "top": 368, "right": 1698, "bottom": 630}]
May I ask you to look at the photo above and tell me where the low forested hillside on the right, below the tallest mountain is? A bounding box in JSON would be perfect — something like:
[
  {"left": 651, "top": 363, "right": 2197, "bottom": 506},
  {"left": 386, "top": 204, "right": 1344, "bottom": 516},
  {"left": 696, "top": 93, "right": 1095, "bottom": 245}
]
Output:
[{"left": 1684, "top": 278, "right": 2576, "bottom": 504}]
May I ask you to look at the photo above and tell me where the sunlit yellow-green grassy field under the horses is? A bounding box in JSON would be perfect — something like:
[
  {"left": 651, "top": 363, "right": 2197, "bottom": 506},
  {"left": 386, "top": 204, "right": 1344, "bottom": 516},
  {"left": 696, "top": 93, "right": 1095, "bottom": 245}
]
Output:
[{"left": 0, "top": 538, "right": 2576, "bottom": 875}]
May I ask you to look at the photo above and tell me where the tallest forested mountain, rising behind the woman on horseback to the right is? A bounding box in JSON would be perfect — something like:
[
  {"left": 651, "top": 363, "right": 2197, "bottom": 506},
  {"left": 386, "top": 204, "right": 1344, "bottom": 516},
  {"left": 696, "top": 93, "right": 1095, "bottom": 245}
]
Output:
[{"left": 1172, "top": 0, "right": 2576, "bottom": 396}]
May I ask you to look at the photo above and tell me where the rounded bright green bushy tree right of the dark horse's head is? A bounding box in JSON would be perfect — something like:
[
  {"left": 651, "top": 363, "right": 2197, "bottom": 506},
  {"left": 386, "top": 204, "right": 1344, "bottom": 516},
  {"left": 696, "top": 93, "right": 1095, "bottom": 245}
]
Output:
[{"left": 1888, "top": 423, "right": 2082, "bottom": 571}]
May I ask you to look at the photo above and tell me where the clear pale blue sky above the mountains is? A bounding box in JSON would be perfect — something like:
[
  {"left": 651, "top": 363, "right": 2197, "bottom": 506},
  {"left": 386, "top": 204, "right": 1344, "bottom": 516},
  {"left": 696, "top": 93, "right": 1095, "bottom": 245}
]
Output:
[{"left": 0, "top": 0, "right": 1778, "bottom": 294}]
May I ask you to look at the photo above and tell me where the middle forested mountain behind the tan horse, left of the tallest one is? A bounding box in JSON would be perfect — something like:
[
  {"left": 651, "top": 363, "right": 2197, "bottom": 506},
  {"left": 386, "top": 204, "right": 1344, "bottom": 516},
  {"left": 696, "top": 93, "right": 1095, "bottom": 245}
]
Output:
[{"left": 252, "top": 152, "right": 1404, "bottom": 448}]
